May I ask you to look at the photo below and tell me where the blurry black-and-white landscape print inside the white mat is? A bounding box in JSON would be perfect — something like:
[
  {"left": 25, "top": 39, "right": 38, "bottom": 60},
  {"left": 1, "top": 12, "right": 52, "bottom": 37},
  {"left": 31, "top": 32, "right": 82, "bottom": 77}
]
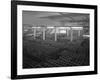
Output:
[{"left": 22, "top": 11, "right": 90, "bottom": 68}]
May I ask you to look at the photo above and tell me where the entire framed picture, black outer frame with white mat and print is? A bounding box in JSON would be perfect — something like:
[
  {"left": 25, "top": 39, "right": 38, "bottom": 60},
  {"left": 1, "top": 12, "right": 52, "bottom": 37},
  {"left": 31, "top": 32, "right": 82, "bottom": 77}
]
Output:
[{"left": 11, "top": 1, "right": 97, "bottom": 79}]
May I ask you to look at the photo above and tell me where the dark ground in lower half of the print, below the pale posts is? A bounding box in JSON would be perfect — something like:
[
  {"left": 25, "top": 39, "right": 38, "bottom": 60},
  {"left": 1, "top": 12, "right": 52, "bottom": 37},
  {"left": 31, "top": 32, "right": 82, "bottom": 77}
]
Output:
[{"left": 23, "top": 36, "right": 89, "bottom": 68}]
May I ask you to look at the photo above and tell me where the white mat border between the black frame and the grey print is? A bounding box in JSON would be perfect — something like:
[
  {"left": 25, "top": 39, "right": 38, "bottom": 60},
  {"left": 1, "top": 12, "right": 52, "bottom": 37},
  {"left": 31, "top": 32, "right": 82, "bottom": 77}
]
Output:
[{"left": 17, "top": 5, "right": 94, "bottom": 75}]
